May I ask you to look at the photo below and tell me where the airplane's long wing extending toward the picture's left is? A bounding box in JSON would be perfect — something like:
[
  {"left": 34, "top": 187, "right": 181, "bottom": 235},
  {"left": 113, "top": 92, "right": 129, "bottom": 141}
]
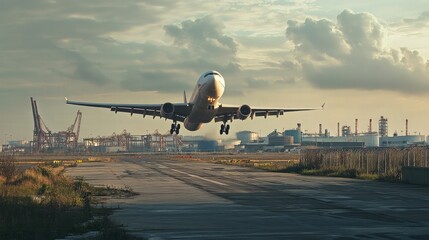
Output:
[{"left": 66, "top": 98, "right": 192, "bottom": 122}]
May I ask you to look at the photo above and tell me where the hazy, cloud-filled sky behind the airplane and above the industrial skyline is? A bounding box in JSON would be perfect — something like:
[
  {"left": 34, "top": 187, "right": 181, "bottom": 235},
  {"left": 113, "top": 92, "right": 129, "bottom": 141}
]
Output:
[{"left": 0, "top": 0, "right": 429, "bottom": 143}]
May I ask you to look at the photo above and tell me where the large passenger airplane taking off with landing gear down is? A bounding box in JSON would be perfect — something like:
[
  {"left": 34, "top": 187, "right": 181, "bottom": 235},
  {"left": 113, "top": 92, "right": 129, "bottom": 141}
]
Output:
[{"left": 66, "top": 71, "right": 325, "bottom": 135}]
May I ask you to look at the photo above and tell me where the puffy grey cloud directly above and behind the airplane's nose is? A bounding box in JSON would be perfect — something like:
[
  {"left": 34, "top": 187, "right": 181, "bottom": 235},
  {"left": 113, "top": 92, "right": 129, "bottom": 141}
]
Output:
[{"left": 120, "top": 16, "right": 245, "bottom": 92}]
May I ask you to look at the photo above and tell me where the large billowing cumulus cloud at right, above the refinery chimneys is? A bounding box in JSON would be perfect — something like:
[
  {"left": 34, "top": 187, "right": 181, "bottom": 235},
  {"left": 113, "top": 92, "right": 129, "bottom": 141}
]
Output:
[{"left": 286, "top": 10, "right": 429, "bottom": 93}]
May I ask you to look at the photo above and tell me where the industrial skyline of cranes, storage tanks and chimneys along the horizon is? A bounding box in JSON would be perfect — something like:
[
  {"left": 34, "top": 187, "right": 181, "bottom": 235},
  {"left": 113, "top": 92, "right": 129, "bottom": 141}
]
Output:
[{"left": 1, "top": 98, "right": 429, "bottom": 153}]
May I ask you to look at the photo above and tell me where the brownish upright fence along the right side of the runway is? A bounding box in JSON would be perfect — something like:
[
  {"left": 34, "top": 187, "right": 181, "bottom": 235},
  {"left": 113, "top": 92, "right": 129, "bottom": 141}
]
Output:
[{"left": 300, "top": 147, "right": 429, "bottom": 176}]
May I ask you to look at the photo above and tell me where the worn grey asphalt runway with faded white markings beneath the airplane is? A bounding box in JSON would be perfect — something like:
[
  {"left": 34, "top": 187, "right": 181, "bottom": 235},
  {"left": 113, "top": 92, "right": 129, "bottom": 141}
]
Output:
[{"left": 67, "top": 159, "right": 429, "bottom": 239}]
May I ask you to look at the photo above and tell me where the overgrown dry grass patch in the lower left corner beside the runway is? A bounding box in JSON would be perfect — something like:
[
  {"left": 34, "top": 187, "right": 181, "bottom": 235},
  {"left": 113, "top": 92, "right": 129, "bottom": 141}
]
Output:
[{"left": 0, "top": 161, "right": 137, "bottom": 239}]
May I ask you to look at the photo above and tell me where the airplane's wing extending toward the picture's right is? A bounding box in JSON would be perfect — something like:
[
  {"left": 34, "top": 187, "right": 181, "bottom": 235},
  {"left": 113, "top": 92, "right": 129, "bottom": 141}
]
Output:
[{"left": 215, "top": 104, "right": 325, "bottom": 122}]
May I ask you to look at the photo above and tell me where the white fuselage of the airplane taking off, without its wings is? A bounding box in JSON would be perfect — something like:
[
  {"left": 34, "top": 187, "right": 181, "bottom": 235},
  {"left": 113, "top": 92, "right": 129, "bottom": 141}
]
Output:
[{"left": 184, "top": 71, "right": 225, "bottom": 131}]
